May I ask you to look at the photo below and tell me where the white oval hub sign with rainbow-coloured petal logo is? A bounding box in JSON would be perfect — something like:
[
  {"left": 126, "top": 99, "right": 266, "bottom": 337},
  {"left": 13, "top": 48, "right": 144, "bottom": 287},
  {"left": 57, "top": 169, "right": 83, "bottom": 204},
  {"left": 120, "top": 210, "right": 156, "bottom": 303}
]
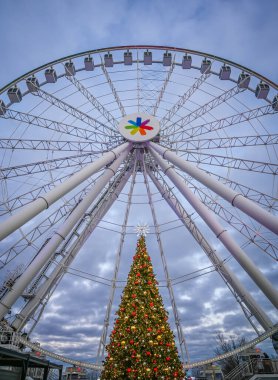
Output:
[{"left": 119, "top": 112, "right": 160, "bottom": 142}]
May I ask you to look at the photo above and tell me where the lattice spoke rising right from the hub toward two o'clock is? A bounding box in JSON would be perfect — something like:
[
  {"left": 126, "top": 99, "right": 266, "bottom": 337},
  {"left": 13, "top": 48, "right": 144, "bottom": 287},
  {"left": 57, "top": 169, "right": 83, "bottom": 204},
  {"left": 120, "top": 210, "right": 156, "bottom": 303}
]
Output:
[{"left": 161, "top": 86, "right": 244, "bottom": 136}]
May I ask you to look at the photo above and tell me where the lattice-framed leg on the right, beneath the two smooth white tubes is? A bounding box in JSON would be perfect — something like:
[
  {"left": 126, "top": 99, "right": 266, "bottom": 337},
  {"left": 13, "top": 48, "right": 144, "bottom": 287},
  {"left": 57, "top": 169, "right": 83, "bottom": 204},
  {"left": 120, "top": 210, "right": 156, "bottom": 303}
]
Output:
[{"left": 148, "top": 170, "right": 273, "bottom": 331}]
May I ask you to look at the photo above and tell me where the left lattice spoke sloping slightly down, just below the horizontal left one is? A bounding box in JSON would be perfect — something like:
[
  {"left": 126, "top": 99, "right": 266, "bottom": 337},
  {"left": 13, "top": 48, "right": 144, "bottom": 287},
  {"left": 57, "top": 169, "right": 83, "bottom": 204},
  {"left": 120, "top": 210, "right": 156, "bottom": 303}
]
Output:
[{"left": 0, "top": 153, "right": 94, "bottom": 180}]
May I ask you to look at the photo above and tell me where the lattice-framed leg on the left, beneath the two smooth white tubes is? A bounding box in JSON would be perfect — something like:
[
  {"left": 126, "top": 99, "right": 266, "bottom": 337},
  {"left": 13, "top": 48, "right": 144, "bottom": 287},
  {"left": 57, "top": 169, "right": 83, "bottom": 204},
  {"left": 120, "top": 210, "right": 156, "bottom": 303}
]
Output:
[{"left": 11, "top": 171, "right": 131, "bottom": 331}]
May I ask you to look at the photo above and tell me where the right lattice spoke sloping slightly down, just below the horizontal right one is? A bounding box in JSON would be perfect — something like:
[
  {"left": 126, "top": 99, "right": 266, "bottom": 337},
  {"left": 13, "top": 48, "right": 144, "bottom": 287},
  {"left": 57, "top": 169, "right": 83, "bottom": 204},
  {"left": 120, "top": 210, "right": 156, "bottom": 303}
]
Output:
[{"left": 182, "top": 151, "right": 278, "bottom": 175}]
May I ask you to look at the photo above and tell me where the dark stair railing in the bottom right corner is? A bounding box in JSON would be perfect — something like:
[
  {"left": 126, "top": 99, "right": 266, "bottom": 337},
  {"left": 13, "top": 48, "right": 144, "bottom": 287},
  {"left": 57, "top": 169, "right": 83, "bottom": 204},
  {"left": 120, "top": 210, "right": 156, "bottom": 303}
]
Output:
[{"left": 225, "top": 358, "right": 278, "bottom": 380}]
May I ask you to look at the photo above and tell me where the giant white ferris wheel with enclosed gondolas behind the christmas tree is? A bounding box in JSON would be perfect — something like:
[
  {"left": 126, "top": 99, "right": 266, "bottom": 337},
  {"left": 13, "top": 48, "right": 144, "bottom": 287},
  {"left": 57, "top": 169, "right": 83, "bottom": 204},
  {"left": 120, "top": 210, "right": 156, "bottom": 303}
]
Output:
[{"left": 0, "top": 46, "right": 278, "bottom": 368}]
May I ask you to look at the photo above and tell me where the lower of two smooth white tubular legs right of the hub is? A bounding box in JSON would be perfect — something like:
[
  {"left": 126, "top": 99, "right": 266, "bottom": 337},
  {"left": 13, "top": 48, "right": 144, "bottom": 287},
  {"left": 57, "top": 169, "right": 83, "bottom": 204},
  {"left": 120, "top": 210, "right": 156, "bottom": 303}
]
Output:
[{"left": 150, "top": 149, "right": 278, "bottom": 308}]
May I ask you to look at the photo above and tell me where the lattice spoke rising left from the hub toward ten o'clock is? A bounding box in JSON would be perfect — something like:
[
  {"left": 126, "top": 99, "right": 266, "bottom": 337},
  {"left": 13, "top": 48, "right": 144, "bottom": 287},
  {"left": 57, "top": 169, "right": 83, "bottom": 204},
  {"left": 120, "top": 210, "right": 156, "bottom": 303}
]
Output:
[{"left": 33, "top": 89, "right": 115, "bottom": 142}]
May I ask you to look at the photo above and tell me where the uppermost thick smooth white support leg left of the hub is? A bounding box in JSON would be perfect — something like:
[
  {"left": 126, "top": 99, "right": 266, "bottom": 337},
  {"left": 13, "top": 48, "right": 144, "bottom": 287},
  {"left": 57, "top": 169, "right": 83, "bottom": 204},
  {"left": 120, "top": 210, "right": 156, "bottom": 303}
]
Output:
[{"left": 0, "top": 143, "right": 129, "bottom": 241}]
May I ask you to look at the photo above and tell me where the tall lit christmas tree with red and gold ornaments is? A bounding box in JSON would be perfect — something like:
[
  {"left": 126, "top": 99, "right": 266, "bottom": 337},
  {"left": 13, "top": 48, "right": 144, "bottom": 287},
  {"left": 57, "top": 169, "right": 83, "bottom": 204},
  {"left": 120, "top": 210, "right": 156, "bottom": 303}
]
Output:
[{"left": 101, "top": 235, "right": 185, "bottom": 380}]
